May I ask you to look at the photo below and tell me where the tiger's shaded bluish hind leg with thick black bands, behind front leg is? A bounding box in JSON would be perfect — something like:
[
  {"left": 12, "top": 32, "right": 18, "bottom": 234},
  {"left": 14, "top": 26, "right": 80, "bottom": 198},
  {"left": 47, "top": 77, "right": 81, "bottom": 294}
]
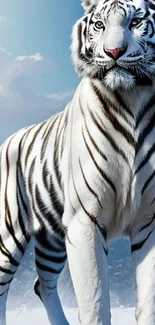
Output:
[{"left": 34, "top": 229, "right": 69, "bottom": 325}]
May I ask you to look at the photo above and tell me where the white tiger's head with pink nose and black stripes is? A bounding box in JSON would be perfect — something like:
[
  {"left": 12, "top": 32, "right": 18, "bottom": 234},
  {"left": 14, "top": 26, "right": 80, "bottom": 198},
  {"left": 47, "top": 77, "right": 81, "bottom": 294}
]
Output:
[{"left": 72, "top": 0, "right": 155, "bottom": 89}]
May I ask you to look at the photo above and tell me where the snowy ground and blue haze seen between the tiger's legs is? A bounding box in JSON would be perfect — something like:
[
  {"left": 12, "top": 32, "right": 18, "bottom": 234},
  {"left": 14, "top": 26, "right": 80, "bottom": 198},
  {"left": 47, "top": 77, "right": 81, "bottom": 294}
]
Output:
[{"left": 7, "top": 237, "right": 136, "bottom": 325}]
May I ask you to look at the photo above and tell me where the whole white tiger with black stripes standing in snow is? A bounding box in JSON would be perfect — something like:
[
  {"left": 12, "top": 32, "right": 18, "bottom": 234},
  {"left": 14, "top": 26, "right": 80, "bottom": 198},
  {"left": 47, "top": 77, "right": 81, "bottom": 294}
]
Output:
[{"left": 0, "top": 0, "right": 155, "bottom": 325}]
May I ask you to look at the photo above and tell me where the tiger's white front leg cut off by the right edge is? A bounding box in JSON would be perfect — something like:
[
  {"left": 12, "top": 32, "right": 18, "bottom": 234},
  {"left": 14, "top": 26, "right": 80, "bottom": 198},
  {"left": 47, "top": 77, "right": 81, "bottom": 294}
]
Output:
[{"left": 131, "top": 220, "right": 155, "bottom": 325}]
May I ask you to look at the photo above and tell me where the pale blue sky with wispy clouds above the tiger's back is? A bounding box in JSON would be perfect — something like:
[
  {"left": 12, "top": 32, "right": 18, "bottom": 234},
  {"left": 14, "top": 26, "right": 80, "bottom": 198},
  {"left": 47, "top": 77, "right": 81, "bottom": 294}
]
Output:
[{"left": 0, "top": 0, "right": 83, "bottom": 142}]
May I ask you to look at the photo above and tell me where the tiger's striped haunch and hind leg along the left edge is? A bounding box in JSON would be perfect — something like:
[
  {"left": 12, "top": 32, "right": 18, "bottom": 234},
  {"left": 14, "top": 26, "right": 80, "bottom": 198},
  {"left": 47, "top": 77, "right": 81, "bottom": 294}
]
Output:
[{"left": 0, "top": 129, "right": 30, "bottom": 325}]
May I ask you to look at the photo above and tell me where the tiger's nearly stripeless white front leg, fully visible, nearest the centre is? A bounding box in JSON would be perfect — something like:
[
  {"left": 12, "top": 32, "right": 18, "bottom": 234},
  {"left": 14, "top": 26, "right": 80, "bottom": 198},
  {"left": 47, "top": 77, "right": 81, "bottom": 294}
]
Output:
[{"left": 66, "top": 211, "right": 111, "bottom": 325}]
